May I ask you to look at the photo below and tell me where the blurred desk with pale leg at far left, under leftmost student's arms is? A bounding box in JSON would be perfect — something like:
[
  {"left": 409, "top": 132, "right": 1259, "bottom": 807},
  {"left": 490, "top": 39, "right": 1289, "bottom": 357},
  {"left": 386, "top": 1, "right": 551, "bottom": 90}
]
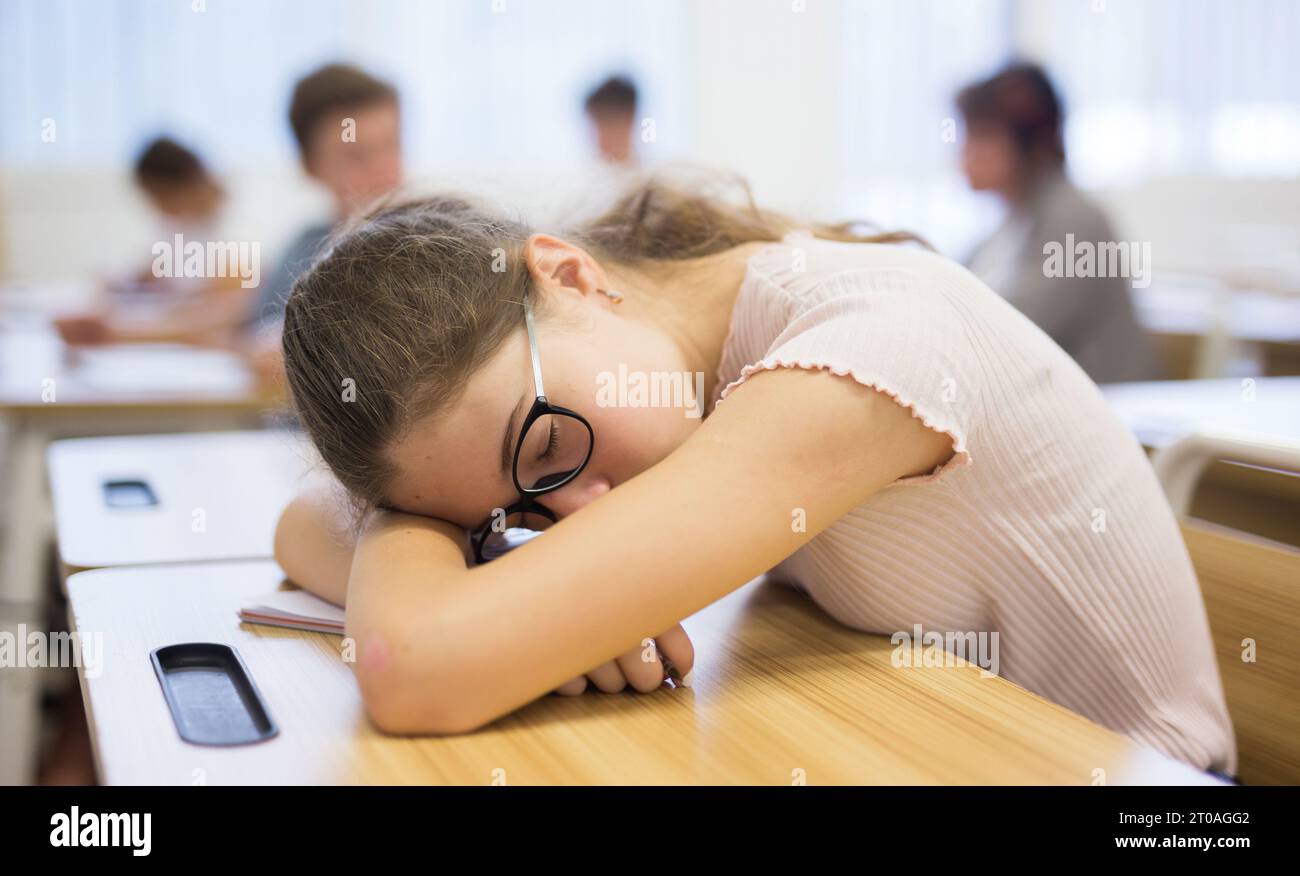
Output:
[{"left": 0, "top": 317, "right": 276, "bottom": 784}]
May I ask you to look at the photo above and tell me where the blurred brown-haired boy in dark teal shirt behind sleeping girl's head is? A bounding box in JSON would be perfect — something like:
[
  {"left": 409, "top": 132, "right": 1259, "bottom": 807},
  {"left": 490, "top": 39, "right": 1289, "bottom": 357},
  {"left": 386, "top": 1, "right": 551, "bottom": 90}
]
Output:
[{"left": 250, "top": 64, "right": 402, "bottom": 327}]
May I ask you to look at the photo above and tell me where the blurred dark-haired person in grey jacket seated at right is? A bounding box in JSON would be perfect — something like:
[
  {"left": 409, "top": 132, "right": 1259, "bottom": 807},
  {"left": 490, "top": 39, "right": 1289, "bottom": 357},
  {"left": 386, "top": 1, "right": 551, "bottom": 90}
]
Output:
[{"left": 957, "top": 64, "right": 1160, "bottom": 383}]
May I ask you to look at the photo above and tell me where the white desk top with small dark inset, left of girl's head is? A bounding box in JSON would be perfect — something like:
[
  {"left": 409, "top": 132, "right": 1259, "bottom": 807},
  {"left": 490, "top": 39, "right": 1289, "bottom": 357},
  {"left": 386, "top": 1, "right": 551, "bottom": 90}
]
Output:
[{"left": 48, "top": 430, "right": 316, "bottom": 569}]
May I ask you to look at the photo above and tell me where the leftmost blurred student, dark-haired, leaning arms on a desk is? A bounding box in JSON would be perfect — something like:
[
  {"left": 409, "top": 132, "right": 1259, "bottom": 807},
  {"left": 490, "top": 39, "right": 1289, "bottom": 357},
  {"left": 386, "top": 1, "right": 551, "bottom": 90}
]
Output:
[{"left": 56, "top": 136, "right": 255, "bottom": 343}]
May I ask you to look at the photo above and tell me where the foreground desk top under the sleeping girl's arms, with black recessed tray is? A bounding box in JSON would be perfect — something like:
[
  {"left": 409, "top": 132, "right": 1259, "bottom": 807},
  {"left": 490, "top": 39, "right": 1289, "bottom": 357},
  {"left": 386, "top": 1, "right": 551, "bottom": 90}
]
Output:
[{"left": 68, "top": 563, "right": 1216, "bottom": 785}]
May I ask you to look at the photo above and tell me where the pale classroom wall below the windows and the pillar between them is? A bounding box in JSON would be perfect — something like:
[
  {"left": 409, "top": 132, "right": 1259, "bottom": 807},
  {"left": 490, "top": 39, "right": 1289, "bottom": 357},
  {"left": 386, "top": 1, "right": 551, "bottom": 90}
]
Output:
[{"left": 0, "top": 0, "right": 1300, "bottom": 286}]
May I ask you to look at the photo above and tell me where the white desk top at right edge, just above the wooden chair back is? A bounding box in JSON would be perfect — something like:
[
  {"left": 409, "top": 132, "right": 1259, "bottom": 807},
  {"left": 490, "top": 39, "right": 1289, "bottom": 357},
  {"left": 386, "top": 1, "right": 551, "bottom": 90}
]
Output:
[{"left": 1101, "top": 377, "right": 1300, "bottom": 447}]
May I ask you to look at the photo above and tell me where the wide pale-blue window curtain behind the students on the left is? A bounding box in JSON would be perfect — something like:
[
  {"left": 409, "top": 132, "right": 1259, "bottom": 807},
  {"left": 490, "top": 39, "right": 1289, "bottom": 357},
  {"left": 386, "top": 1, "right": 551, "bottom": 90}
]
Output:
[{"left": 0, "top": 0, "right": 689, "bottom": 173}]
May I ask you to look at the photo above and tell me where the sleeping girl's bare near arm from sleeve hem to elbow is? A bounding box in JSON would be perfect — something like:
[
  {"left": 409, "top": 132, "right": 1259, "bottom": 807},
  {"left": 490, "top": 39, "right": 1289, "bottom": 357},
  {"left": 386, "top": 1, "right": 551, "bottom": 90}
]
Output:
[{"left": 347, "top": 369, "right": 953, "bottom": 733}]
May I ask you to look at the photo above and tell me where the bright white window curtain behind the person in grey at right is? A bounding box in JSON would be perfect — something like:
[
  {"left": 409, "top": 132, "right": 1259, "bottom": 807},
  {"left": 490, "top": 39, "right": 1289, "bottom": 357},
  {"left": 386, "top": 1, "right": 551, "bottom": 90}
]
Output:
[{"left": 839, "top": 0, "right": 1300, "bottom": 256}]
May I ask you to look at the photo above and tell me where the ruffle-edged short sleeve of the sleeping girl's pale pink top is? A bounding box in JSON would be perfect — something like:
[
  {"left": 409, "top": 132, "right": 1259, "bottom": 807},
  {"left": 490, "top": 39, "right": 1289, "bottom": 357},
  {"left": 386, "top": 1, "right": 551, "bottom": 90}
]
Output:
[{"left": 719, "top": 269, "right": 978, "bottom": 483}]
